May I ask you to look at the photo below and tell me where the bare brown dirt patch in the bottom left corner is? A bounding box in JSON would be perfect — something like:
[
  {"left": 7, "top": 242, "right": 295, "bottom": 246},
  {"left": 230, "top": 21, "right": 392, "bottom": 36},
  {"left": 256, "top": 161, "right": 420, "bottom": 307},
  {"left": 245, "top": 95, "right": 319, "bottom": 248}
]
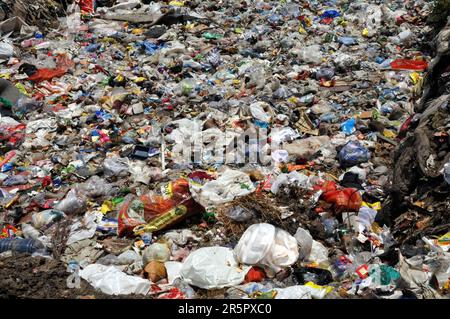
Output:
[{"left": 0, "top": 255, "right": 148, "bottom": 299}]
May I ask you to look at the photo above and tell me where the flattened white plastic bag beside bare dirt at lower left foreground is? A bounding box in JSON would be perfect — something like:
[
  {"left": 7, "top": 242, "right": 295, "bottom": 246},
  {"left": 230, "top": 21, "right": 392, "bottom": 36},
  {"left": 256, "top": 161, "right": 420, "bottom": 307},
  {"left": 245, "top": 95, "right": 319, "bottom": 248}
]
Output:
[{"left": 80, "top": 264, "right": 151, "bottom": 295}]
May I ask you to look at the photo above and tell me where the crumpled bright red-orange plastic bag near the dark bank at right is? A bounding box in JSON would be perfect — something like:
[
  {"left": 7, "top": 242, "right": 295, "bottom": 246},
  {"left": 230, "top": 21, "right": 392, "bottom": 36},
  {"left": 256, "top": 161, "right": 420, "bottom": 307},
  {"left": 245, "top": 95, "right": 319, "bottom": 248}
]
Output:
[{"left": 321, "top": 188, "right": 362, "bottom": 212}]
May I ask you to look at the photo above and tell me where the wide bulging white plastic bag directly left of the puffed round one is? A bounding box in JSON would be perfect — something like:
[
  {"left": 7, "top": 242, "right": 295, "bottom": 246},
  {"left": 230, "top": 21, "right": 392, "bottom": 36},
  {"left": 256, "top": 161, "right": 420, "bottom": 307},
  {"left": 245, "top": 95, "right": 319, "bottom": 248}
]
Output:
[{"left": 180, "top": 246, "right": 250, "bottom": 289}]
